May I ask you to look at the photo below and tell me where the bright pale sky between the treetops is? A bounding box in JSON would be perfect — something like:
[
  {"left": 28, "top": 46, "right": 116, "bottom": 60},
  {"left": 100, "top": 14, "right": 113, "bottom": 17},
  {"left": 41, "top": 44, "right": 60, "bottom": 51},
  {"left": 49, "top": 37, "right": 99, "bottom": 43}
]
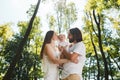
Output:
[{"left": 0, "top": 0, "right": 86, "bottom": 32}]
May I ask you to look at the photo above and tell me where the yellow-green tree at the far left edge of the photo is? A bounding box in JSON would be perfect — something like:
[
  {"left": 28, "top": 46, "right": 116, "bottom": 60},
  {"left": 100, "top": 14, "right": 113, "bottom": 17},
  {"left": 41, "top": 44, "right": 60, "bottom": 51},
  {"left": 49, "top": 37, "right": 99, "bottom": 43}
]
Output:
[{"left": 0, "top": 23, "right": 14, "bottom": 79}]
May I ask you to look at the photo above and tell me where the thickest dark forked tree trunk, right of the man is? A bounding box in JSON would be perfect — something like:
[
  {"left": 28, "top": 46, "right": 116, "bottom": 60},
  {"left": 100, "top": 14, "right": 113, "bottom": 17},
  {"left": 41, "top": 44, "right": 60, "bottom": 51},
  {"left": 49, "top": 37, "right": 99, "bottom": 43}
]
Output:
[{"left": 93, "top": 10, "right": 108, "bottom": 80}]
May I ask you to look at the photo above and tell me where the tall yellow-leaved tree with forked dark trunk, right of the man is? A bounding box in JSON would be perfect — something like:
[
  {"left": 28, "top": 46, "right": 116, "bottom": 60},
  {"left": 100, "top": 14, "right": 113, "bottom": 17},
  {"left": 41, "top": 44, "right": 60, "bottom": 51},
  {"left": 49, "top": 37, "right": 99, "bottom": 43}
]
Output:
[{"left": 85, "top": 0, "right": 119, "bottom": 80}]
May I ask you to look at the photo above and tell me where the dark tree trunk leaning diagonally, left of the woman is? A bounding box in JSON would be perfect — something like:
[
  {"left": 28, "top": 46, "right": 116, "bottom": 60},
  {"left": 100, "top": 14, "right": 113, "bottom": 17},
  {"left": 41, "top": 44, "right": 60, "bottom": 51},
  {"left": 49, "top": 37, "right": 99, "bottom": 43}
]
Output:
[{"left": 3, "top": 0, "right": 41, "bottom": 80}]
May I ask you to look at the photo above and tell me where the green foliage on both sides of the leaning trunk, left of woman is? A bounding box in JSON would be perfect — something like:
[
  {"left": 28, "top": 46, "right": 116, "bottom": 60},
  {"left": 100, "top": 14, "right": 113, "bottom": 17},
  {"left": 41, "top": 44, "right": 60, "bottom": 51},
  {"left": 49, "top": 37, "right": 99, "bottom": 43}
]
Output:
[{"left": 0, "top": 2, "right": 43, "bottom": 80}]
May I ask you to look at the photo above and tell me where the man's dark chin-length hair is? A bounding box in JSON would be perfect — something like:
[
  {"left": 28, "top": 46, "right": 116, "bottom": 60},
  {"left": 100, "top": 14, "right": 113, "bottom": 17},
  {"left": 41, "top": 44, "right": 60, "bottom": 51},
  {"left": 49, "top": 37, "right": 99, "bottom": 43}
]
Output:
[{"left": 69, "top": 28, "right": 83, "bottom": 42}]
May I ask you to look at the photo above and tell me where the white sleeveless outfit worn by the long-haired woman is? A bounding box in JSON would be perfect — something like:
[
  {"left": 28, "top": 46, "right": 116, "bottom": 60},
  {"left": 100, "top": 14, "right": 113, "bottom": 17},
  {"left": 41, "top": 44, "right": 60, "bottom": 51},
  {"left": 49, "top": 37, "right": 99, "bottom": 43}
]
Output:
[{"left": 43, "top": 49, "right": 60, "bottom": 80}]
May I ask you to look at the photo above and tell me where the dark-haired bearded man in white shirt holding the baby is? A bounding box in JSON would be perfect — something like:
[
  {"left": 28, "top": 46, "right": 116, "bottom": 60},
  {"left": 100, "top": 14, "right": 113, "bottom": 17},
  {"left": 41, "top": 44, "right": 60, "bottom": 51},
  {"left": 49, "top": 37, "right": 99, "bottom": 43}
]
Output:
[{"left": 62, "top": 28, "right": 86, "bottom": 80}]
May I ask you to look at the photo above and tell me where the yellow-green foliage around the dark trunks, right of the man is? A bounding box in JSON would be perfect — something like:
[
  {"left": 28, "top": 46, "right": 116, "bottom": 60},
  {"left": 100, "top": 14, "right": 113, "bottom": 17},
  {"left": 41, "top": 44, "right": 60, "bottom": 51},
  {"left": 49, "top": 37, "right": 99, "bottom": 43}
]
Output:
[{"left": 83, "top": 0, "right": 120, "bottom": 80}]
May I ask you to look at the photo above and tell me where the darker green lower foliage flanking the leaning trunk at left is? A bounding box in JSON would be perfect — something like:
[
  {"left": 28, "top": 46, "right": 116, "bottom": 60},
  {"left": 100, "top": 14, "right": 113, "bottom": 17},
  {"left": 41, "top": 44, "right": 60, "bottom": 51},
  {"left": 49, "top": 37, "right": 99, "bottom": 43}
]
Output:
[{"left": 0, "top": 35, "right": 43, "bottom": 80}]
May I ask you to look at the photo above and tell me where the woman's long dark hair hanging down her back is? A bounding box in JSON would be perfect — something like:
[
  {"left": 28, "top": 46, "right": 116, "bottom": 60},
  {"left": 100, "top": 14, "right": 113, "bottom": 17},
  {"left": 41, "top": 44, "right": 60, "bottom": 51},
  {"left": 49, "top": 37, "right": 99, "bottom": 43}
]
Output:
[{"left": 40, "top": 30, "right": 54, "bottom": 59}]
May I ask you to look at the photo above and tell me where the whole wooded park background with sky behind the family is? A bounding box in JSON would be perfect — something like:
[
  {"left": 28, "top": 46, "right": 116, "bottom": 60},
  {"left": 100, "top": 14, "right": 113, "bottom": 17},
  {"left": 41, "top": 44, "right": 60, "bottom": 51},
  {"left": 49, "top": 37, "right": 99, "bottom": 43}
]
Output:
[{"left": 0, "top": 0, "right": 120, "bottom": 80}]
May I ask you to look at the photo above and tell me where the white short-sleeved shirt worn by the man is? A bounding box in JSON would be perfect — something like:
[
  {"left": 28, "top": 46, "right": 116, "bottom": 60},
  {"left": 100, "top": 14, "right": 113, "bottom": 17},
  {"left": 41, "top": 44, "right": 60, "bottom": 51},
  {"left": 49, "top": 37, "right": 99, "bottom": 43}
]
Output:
[{"left": 61, "top": 42, "right": 86, "bottom": 79}]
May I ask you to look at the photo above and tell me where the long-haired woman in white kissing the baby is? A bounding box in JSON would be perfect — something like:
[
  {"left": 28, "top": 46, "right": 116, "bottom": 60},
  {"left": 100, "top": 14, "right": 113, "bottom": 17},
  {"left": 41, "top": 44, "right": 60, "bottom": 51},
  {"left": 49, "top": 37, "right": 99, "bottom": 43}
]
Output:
[{"left": 40, "top": 31, "right": 68, "bottom": 80}]
